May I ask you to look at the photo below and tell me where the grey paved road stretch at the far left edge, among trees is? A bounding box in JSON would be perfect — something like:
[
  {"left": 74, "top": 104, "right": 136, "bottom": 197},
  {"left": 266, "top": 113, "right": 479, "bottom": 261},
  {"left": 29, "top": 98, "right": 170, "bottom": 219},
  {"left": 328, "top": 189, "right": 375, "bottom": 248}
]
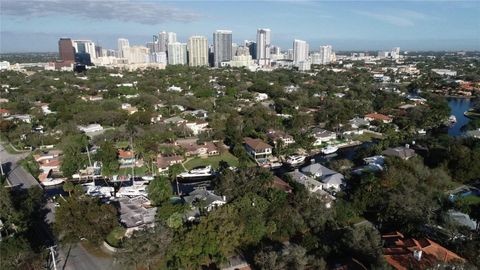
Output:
[{"left": 0, "top": 144, "right": 40, "bottom": 189}]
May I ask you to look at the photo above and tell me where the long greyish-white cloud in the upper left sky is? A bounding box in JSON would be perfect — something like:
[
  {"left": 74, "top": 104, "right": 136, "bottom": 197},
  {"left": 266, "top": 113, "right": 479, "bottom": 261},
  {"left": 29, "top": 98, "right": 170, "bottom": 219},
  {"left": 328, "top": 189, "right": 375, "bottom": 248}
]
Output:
[{"left": 1, "top": 0, "right": 201, "bottom": 25}]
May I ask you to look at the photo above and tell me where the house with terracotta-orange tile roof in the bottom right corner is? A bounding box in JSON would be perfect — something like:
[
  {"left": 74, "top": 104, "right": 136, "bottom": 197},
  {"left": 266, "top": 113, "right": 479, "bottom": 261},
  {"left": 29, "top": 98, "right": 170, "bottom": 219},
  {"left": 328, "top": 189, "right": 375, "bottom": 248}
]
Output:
[{"left": 382, "top": 232, "right": 465, "bottom": 270}]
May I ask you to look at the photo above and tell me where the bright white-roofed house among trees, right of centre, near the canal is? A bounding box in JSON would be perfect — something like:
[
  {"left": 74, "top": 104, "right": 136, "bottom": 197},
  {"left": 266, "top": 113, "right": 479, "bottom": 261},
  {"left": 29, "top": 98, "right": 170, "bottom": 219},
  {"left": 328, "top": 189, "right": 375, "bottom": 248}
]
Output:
[{"left": 301, "top": 163, "right": 345, "bottom": 191}]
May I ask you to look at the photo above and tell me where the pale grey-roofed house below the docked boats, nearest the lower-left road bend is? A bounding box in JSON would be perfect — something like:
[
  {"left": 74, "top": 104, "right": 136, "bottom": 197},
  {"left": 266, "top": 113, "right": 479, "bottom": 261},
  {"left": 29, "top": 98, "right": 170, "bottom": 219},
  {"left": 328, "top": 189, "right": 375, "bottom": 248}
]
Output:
[{"left": 118, "top": 196, "right": 157, "bottom": 235}]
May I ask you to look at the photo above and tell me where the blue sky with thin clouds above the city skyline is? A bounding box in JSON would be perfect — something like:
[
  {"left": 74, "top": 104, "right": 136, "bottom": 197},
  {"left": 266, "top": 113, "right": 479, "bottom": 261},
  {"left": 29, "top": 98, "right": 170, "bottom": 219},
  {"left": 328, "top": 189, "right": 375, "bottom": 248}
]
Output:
[{"left": 0, "top": 0, "right": 480, "bottom": 53}]
